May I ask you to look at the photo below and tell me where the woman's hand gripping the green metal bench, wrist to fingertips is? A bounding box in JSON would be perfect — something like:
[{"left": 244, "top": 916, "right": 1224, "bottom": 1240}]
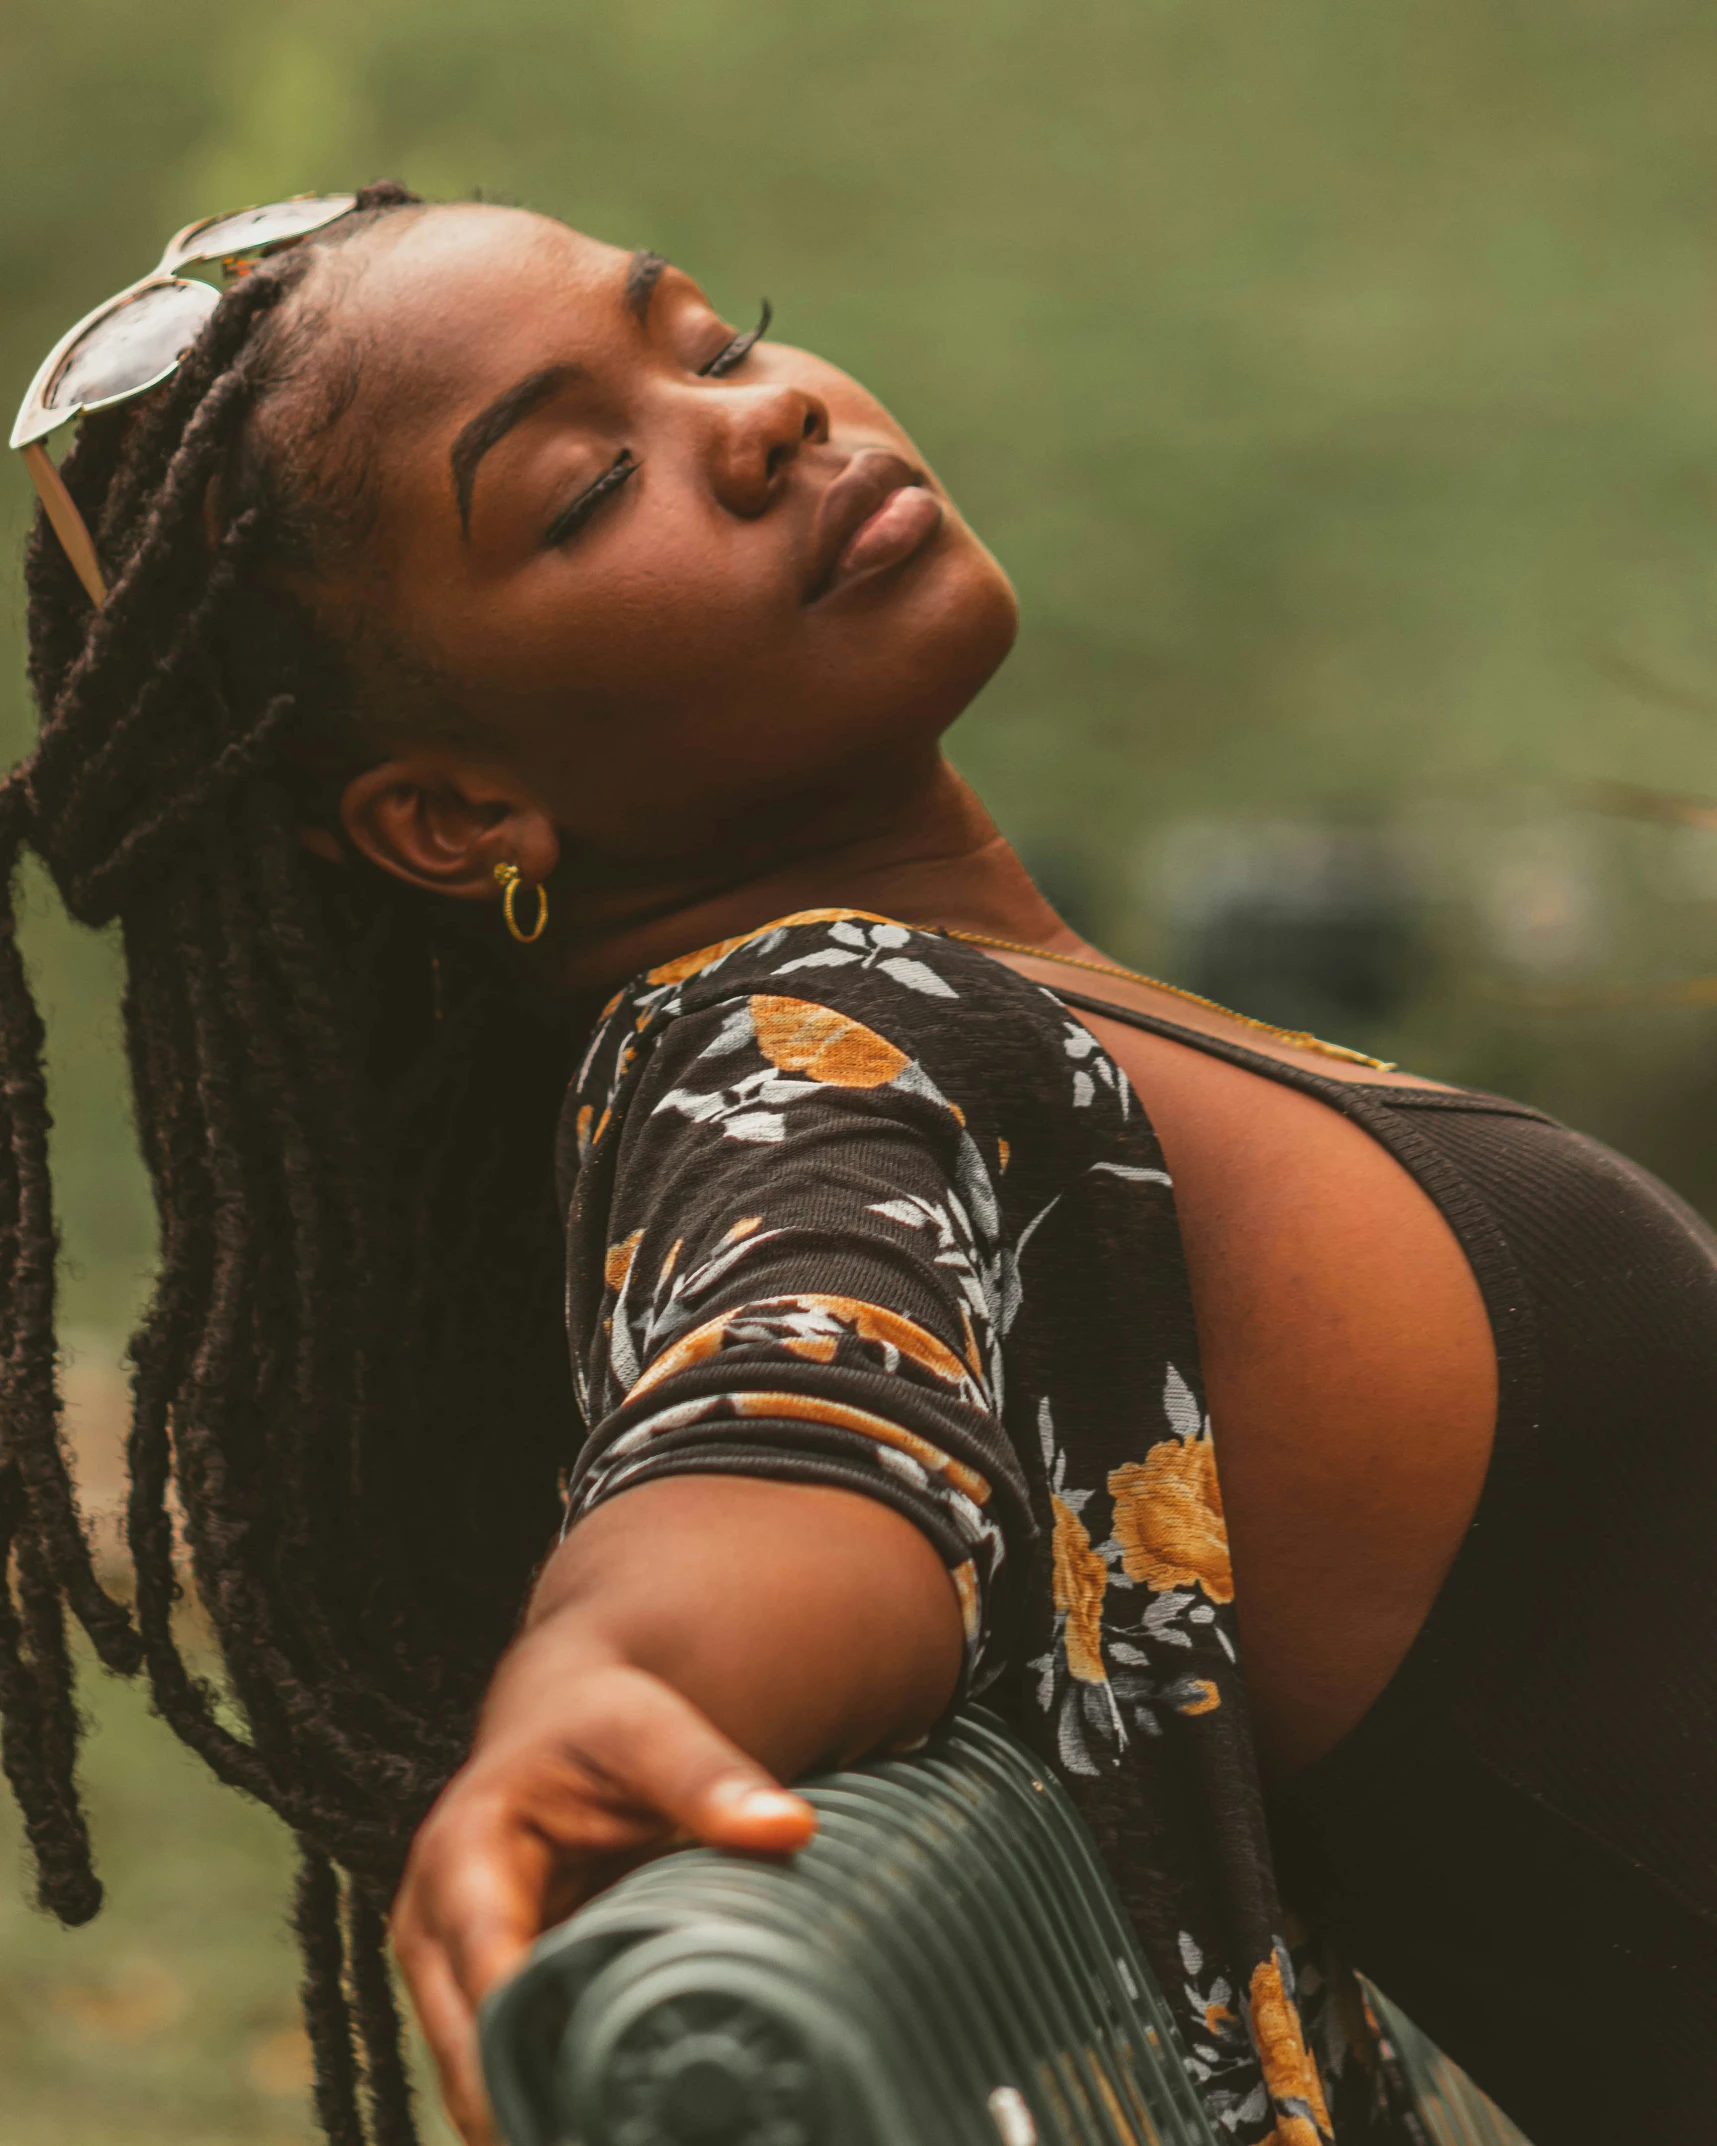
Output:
[{"left": 393, "top": 1627, "right": 816, "bottom": 2146}]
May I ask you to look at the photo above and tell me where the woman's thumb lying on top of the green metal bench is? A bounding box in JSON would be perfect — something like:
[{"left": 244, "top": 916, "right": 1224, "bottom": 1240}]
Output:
[{"left": 579, "top": 1670, "right": 818, "bottom": 1854}]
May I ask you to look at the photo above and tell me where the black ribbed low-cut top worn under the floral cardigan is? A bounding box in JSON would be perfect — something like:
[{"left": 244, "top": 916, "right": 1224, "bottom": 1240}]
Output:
[{"left": 1056, "top": 991, "right": 1717, "bottom": 2146}]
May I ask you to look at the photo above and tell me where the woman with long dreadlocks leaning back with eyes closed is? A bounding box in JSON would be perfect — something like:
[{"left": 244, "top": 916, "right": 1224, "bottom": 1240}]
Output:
[{"left": 0, "top": 189, "right": 1717, "bottom": 2146}]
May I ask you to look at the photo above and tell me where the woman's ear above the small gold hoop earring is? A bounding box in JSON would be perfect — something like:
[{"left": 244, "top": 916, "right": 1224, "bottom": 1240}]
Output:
[{"left": 339, "top": 751, "right": 560, "bottom": 901}]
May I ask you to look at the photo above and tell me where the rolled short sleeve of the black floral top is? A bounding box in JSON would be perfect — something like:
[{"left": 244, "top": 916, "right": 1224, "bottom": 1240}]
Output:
[{"left": 569, "top": 969, "right": 1034, "bottom": 1693}]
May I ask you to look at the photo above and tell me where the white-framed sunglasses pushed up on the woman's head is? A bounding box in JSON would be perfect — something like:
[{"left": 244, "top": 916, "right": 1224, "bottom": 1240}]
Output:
[{"left": 11, "top": 193, "right": 358, "bottom": 603}]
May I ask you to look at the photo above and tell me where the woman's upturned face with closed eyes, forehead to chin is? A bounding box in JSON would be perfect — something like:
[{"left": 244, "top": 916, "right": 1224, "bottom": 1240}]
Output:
[{"left": 291, "top": 206, "right": 1015, "bottom": 861}]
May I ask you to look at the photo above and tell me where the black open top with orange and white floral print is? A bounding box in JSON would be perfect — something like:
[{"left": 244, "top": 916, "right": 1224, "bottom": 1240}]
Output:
[{"left": 560, "top": 910, "right": 1410, "bottom": 2146}]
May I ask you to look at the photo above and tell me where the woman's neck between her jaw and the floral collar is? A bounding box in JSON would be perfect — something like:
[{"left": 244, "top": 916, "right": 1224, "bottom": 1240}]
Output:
[{"left": 539, "top": 755, "right": 1082, "bottom": 1011}]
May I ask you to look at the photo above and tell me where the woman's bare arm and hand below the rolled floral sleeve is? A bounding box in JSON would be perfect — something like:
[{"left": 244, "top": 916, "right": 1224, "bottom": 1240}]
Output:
[{"left": 393, "top": 1476, "right": 962, "bottom": 2146}]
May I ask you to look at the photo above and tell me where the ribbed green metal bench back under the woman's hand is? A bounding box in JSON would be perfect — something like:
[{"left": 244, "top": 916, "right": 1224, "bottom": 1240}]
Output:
[{"left": 483, "top": 1713, "right": 1219, "bottom": 2146}]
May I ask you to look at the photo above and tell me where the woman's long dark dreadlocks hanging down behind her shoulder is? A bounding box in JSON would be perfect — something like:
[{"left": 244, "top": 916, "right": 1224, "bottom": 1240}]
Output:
[{"left": 0, "top": 185, "right": 571, "bottom": 2146}]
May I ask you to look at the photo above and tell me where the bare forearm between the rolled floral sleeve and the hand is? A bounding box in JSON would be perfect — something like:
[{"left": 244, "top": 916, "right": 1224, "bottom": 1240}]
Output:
[{"left": 476, "top": 1476, "right": 962, "bottom": 1781}]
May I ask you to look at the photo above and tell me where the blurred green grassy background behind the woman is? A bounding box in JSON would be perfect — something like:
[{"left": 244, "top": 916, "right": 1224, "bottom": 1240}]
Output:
[{"left": 0, "top": 0, "right": 1717, "bottom": 2146}]
